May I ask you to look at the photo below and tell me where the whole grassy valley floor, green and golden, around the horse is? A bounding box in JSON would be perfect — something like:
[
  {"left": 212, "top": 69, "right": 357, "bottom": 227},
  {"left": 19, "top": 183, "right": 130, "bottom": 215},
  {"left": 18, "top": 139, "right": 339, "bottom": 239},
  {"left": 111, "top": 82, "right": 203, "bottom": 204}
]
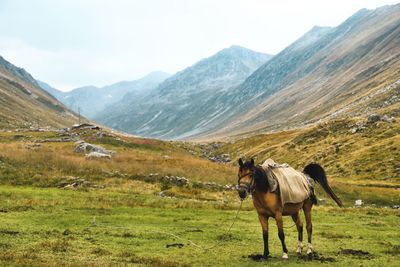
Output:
[{"left": 0, "top": 129, "right": 400, "bottom": 266}]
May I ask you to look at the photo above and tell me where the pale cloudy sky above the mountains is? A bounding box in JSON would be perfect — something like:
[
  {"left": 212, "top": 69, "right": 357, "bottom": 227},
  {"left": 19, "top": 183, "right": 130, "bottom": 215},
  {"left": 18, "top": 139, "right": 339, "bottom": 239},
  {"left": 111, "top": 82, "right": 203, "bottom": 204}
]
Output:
[{"left": 0, "top": 0, "right": 399, "bottom": 91}]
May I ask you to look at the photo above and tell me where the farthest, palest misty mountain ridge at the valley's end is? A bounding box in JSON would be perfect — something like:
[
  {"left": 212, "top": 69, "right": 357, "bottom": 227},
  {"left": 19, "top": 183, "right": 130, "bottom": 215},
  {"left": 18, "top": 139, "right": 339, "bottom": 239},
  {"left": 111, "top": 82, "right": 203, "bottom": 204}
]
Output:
[{"left": 39, "top": 71, "right": 170, "bottom": 119}]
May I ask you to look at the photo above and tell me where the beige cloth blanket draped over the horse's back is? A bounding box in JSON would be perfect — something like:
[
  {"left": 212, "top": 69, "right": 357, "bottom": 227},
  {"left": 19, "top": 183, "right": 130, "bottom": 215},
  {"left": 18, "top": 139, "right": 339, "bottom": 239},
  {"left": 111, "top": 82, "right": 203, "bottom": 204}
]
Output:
[{"left": 261, "top": 159, "right": 312, "bottom": 207}]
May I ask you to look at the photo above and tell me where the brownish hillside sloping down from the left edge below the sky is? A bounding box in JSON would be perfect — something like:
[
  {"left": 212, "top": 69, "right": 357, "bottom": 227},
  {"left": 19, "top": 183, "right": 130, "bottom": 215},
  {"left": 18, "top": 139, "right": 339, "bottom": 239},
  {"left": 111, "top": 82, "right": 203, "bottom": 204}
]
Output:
[{"left": 0, "top": 56, "right": 78, "bottom": 129}]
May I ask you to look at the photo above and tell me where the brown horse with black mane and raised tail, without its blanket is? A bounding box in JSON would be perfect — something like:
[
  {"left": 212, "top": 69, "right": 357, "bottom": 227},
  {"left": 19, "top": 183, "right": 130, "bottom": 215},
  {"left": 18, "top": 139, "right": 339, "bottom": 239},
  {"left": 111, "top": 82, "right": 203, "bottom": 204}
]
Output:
[{"left": 238, "top": 159, "right": 343, "bottom": 260}]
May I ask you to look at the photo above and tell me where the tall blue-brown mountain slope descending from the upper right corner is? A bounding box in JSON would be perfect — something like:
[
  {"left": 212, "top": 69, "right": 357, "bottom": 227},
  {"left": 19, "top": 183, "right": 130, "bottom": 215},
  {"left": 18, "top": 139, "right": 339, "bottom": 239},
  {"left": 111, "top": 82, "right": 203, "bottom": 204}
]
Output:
[{"left": 197, "top": 4, "right": 400, "bottom": 138}]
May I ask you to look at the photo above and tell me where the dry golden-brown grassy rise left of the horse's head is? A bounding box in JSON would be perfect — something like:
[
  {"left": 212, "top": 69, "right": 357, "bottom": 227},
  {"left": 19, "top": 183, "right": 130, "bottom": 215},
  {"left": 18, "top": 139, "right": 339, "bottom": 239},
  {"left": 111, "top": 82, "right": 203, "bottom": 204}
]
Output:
[{"left": 0, "top": 128, "right": 235, "bottom": 186}]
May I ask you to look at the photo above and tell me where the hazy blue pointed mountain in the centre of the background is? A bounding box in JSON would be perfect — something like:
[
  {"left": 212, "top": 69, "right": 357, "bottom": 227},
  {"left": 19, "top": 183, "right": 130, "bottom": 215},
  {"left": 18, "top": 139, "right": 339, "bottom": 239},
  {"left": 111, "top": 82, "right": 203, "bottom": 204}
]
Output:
[{"left": 95, "top": 46, "right": 271, "bottom": 139}]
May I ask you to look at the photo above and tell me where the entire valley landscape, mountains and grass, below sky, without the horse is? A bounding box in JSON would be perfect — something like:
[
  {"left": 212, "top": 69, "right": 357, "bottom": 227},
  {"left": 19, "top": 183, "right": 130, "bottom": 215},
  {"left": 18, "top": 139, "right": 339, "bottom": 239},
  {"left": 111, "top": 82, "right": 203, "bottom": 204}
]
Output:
[{"left": 0, "top": 4, "right": 400, "bottom": 267}]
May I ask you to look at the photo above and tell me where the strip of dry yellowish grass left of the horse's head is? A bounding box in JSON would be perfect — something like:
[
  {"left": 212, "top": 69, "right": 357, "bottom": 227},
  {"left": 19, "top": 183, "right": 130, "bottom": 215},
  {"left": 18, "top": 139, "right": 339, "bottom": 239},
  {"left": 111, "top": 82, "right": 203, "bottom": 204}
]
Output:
[{"left": 0, "top": 134, "right": 235, "bottom": 188}]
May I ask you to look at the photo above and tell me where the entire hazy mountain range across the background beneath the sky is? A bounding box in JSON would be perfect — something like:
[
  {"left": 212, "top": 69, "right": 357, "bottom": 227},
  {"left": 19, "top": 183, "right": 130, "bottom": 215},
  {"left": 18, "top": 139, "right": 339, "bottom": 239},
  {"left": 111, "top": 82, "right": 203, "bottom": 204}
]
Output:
[{"left": 0, "top": 4, "right": 400, "bottom": 142}]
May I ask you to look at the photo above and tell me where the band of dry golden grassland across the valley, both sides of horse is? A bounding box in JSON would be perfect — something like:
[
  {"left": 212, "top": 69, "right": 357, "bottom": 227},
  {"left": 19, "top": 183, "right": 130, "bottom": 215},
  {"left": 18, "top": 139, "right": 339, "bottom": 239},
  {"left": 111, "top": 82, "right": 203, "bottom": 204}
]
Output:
[{"left": 0, "top": 119, "right": 400, "bottom": 206}]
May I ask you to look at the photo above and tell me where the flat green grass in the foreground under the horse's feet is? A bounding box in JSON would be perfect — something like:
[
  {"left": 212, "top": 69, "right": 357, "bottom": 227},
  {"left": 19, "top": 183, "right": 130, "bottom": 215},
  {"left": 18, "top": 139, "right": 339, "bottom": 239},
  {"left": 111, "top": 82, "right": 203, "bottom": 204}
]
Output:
[{"left": 0, "top": 187, "right": 400, "bottom": 266}]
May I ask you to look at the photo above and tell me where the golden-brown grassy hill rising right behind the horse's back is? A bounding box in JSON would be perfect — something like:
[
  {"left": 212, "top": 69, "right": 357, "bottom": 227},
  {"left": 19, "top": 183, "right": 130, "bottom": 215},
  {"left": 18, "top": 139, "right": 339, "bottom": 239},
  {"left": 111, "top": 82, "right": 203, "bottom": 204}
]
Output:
[{"left": 205, "top": 118, "right": 400, "bottom": 205}]
